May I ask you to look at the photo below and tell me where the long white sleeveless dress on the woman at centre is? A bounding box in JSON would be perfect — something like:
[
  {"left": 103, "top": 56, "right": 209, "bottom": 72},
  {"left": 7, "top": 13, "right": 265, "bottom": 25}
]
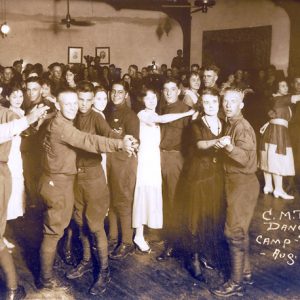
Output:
[{"left": 132, "top": 110, "right": 163, "bottom": 228}]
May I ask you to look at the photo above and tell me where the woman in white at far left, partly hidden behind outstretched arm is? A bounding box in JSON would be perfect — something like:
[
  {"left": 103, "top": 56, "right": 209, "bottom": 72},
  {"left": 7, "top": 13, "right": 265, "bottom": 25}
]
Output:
[{"left": 7, "top": 85, "right": 25, "bottom": 220}]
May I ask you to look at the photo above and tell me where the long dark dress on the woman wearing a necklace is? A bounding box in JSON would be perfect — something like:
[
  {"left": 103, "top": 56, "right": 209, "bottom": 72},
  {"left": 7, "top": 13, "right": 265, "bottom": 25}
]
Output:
[{"left": 183, "top": 118, "right": 225, "bottom": 265}]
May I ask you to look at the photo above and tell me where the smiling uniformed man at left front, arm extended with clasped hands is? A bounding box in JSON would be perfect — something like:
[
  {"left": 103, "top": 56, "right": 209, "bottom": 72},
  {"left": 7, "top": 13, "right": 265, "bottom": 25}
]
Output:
[{"left": 39, "top": 89, "right": 134, "bottom": 289}]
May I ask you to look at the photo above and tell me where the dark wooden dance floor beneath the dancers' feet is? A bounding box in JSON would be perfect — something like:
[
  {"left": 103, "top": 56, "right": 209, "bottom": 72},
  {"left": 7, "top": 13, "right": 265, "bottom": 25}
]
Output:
[{"left": 0, "top": 182, "right": 300, "bottom": 300}]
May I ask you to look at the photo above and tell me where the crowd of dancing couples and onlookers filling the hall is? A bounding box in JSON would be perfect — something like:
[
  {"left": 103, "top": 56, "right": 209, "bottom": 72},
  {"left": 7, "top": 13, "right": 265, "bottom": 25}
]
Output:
[{"left": 0, "top": 52, "right": 300, "bottom": 299}]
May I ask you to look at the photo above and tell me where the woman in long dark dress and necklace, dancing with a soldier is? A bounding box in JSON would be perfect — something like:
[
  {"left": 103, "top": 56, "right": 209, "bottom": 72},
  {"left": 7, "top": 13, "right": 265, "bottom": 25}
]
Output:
[{"left": 184, "top": 89, "right": 225, "bottom": 280}]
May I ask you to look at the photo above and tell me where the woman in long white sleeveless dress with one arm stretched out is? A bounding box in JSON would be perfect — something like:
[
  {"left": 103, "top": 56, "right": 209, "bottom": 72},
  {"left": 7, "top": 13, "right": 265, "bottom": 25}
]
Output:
[{"left": 132, "top": 89, "right": 195, "bottom": 253}]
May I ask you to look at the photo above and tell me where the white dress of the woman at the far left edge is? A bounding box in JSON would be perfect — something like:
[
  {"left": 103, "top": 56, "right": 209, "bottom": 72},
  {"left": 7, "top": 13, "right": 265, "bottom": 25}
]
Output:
[{"left": 7, "top": 109, "right": 25, "bottom": 220}]
